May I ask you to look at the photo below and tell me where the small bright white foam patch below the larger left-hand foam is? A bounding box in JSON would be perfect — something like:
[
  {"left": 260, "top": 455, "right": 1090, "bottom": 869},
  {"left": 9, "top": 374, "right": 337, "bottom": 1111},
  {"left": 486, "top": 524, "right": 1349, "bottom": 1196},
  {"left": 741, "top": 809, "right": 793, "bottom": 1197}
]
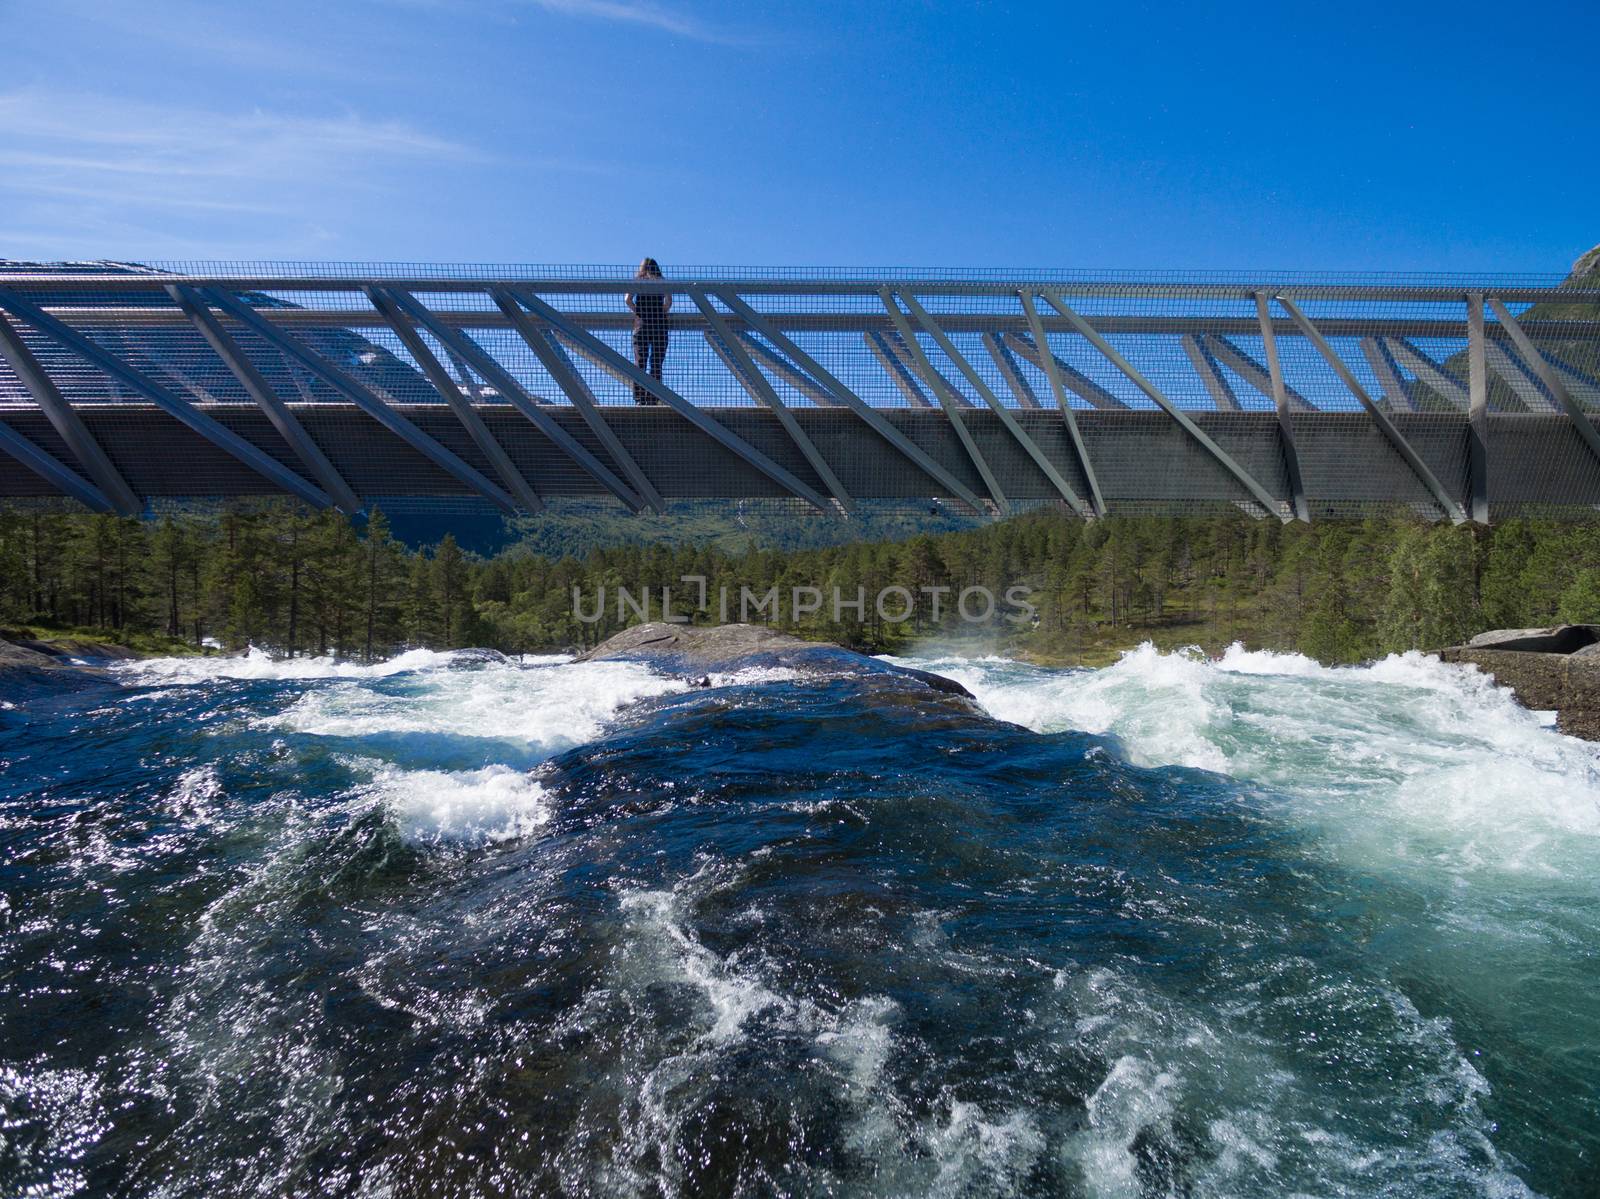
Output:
[{"left": 368, "top": 765, "right": 550, "bottom": 845}]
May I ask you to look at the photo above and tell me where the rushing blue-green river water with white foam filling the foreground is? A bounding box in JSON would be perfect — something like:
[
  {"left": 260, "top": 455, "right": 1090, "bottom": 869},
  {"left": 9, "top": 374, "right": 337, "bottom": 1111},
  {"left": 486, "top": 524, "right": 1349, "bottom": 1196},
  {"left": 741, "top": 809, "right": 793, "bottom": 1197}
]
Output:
[{"left": 0, "top": 650, "right": 1600, "bottom": 1196}]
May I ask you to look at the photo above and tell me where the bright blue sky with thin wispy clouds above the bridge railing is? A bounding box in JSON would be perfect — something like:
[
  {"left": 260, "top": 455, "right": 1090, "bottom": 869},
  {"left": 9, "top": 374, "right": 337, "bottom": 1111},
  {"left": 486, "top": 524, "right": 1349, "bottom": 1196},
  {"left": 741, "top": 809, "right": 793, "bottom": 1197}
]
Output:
[{"left": 0, "top": 0, "right": 1600, "bottom": 272}]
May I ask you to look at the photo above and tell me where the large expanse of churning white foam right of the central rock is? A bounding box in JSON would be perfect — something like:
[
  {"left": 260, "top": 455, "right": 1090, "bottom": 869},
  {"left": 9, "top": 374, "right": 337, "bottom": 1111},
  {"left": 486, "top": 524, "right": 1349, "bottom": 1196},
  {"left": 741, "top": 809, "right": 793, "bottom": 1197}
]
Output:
[{"left": 909, "top": 644, "right": 1600, "bottom": 877}]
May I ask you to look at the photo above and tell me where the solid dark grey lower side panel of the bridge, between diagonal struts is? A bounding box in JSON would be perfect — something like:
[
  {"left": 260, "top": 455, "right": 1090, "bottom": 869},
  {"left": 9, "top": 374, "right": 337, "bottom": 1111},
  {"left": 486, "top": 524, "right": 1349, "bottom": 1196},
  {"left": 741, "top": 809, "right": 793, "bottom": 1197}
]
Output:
[{"left": 0, "top": 403, "right": 1600, "bottom": 519}]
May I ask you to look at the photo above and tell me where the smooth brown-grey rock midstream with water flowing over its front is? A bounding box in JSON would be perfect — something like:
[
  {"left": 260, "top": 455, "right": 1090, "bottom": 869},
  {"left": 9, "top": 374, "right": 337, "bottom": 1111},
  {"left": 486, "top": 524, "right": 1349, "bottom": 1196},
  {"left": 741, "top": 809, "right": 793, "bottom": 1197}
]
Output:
[{"left": 578, "top": 621, "right": 973, "bottom": 700}]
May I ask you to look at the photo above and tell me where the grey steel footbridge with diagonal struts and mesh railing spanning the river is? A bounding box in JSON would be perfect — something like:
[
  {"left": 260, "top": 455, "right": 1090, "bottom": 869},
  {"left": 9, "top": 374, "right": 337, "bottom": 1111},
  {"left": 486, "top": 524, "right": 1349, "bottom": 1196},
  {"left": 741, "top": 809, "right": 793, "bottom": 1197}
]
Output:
[{"left": 0, "top": 263, "right": 1600, "bottom": 522}]
